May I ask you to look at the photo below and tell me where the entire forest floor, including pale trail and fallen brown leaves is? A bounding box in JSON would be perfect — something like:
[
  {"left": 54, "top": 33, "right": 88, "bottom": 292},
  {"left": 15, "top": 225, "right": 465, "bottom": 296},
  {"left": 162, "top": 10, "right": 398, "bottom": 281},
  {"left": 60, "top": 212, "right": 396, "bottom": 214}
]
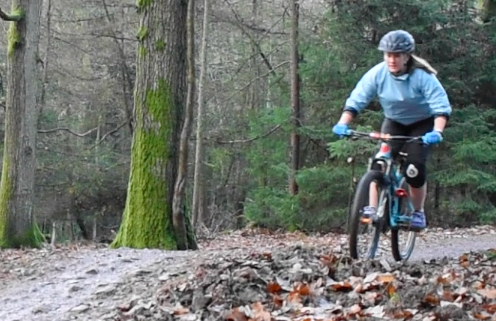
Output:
[{"left": 0, "top": 226, "right": 496, "bottom": 321}]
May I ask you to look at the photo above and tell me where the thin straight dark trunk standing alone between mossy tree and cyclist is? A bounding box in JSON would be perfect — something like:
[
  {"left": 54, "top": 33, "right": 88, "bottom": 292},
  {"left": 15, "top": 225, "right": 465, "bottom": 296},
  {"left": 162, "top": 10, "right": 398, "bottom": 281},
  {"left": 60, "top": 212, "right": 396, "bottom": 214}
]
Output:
[{"left": 289, "top": 0, "right": 301, "bottom": 195}]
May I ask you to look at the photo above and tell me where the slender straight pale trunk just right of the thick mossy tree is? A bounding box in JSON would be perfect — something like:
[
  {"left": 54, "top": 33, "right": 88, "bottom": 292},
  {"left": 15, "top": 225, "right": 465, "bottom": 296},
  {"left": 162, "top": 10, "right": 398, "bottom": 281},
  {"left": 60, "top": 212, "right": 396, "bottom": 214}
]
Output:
[{"left": 191, "top": 0, "right": 210, "bottom": 229}]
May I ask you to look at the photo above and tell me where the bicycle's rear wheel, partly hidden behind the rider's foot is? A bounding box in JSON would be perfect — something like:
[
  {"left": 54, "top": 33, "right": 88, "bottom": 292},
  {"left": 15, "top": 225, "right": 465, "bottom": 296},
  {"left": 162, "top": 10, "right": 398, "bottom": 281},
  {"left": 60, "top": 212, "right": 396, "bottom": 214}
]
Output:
[{"left": 391, "top": 178, "right": 417, "bottom": 262}]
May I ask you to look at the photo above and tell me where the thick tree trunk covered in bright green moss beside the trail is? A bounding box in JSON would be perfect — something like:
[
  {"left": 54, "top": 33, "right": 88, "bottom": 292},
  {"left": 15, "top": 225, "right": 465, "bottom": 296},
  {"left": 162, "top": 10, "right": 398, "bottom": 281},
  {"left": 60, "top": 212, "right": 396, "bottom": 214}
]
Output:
[{"left": 112, "top": 0, "right": 192, "bottom": 249}]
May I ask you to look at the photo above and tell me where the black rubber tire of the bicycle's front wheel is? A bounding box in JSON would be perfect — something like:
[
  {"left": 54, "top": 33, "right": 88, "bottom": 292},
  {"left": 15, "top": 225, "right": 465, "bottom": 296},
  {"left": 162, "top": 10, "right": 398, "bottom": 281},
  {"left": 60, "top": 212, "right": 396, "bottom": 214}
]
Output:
[{"left": 348, "top": 170, "right": 387, "bottom": 259}]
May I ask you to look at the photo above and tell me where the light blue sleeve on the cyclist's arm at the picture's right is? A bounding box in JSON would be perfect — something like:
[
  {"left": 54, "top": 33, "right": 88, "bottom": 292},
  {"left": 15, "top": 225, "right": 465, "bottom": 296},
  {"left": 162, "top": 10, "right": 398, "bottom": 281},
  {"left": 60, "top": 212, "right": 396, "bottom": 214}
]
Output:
[{"left": 422, "top": 72, "right": 451, "bottom": 118}]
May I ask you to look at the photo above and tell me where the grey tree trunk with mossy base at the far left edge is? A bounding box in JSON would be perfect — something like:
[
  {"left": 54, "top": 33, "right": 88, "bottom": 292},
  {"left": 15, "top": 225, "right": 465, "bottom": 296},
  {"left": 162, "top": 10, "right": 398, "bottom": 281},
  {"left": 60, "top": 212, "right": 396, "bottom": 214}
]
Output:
[{"left": 0, "top": 0, "right": 43, "bottom": 247}]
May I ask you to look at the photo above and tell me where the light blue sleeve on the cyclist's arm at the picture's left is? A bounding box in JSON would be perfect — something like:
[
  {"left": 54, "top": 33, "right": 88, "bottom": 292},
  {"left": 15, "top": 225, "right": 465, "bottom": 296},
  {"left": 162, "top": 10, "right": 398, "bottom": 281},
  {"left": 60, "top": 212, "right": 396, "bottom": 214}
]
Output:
[{"left": 344, "top": 68, "right": 377, "bottom": 115}]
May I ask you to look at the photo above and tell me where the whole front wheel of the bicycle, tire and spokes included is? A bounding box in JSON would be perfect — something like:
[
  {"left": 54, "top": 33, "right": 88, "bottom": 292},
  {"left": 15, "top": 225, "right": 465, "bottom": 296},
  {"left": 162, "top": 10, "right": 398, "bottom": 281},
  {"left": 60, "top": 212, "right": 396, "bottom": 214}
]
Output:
[{"left": 348, "top": 170, "right": 388, "bottom": 259}]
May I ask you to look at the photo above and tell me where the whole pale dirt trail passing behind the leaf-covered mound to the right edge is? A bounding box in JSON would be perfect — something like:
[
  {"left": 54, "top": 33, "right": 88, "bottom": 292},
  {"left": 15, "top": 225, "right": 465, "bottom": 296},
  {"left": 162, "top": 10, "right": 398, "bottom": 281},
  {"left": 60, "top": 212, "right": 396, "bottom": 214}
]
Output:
[{"left": 0, "top": 226, "right": 496, "bottom": 321}]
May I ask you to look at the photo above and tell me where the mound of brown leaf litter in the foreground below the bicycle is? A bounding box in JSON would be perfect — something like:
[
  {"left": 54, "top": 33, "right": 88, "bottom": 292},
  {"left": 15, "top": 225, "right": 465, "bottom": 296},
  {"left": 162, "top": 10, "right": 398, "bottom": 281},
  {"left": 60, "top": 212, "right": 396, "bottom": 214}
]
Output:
[{"left": 105, "top": 242, "right": 496, "bottom": 321}]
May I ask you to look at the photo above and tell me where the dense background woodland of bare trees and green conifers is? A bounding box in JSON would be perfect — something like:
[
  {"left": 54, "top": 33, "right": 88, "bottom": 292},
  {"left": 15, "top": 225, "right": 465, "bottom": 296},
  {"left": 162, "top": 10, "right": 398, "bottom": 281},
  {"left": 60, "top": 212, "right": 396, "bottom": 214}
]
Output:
[{"left": 0, "top": 0, "right": 496, "bottom": 245}]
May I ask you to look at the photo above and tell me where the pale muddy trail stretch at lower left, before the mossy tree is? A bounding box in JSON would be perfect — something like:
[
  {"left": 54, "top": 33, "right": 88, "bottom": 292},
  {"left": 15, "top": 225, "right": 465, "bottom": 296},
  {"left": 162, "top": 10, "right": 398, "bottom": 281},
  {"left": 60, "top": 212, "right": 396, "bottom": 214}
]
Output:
[{"left": 0, "top": 248, "right": 190, "bottom": 321}]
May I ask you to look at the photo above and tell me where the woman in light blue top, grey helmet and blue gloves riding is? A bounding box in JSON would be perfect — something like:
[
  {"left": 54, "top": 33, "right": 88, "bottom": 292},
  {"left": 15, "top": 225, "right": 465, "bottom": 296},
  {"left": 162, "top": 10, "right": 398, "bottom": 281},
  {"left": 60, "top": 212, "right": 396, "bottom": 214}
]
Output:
[{"left": 333, "top": 30, "right": 451, "bottom": 230}]
